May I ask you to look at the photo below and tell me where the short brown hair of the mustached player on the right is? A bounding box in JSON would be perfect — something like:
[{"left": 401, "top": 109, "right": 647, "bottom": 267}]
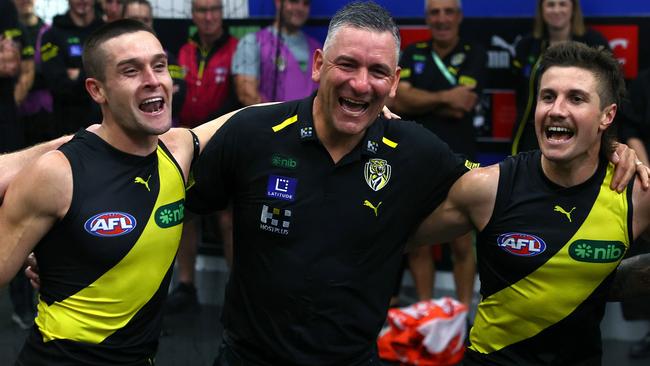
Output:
[{"left": 539, "top": 41, "right": 625, "bottom": 156}]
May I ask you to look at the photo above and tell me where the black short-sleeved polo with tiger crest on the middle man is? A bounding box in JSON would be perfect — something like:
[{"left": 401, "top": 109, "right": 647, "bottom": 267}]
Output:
[{"left": 188, "top": 97, "right": 466, "bottom": 365}]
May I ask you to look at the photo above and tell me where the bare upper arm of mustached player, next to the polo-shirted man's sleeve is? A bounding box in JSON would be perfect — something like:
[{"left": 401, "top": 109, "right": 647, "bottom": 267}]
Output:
[{"left": 407, "top": 165, "right": 499, "bottom": 249}]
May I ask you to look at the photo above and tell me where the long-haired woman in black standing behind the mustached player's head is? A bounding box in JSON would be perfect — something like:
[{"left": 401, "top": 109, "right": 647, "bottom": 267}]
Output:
[{"left": 511, "top": 0, "right": 609, "bottom": 155}]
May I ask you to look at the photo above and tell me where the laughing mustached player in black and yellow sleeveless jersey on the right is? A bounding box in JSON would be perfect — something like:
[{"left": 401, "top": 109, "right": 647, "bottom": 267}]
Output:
[{"left": 414, "top": 42, "right": 650, "bottom": 365}]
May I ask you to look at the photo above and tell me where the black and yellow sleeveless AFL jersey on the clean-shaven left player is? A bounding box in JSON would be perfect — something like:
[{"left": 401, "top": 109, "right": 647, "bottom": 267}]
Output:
[{"left": 19, "top": 131, "right": 185, "bottom": 365}]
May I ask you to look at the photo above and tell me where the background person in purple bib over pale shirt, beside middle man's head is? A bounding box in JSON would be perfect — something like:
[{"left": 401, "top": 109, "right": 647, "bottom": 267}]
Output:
[{"left": 232, "top": 0, "right": 322, "bottom": 105}]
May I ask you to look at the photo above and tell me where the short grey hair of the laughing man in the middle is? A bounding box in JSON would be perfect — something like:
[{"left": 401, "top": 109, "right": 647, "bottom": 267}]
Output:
[{"left": 323, "top": 1, "right": 401, "bottom": 60}]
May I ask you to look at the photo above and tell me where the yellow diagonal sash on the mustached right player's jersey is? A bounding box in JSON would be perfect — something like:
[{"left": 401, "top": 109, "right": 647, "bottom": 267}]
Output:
[{"left": 470, "top": 164, "right": 630, "bottom": 353}]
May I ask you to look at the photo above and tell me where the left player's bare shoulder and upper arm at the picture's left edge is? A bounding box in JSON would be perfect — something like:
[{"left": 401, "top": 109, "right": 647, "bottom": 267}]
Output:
[{"left": 0, "top": 151, "right": 72, "bottom": 287}]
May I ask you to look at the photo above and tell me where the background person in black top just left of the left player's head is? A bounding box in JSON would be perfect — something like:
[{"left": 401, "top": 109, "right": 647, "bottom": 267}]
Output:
[{"left": 40, "top": 0, "right": 103, "bottom": 136}]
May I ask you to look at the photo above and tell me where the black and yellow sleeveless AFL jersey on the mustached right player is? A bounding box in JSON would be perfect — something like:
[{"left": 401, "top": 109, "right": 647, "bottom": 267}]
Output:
[{"left": 466, "top": 151, "right": 632, "bottom": 365}]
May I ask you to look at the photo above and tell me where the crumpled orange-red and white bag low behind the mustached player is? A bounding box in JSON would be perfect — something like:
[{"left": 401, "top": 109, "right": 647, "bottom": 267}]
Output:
[{"left": 377, "top": 297, "right": 468, "bottom": 366}]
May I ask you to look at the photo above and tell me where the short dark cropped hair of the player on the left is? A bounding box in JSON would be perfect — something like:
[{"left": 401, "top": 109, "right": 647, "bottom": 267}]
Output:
[{"left": 81, "top": 19, "right": 156, "bottom": 81}]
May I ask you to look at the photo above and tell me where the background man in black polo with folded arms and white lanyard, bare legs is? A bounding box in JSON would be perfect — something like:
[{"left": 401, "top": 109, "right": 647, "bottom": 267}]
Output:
[{"left": 394, "top": 0, "right": 478, "bottom": 306}]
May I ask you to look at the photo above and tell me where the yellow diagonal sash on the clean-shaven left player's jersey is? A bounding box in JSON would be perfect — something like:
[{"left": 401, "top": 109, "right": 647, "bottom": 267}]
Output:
[{"left": 36, "top": 147, "right": 185, "bottom": 344}]
